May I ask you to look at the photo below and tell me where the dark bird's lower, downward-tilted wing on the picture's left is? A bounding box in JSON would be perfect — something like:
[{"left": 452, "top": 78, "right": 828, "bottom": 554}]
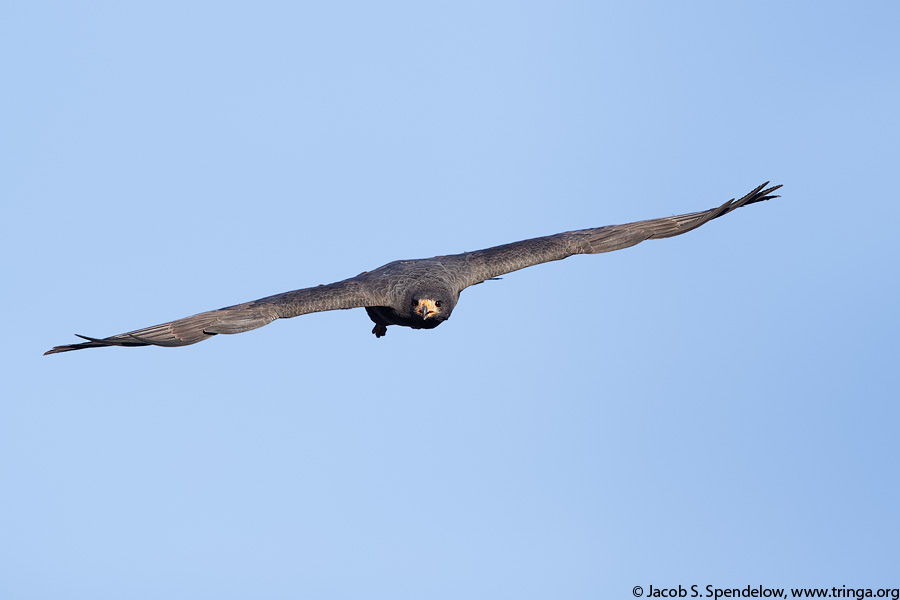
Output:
[{"left": 44, "top": 273, "right": 390, "bottom": 355}]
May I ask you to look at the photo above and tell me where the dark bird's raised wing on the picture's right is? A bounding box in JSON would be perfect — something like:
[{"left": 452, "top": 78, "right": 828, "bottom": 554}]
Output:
[{"left": 459, "top": 182, "right": 781, "bottom": 286}]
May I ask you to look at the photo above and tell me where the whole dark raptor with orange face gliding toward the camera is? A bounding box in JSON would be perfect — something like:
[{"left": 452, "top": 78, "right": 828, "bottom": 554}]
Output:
[{"left": 44, "top": 182, "right": 781, "bottom": 355}]
